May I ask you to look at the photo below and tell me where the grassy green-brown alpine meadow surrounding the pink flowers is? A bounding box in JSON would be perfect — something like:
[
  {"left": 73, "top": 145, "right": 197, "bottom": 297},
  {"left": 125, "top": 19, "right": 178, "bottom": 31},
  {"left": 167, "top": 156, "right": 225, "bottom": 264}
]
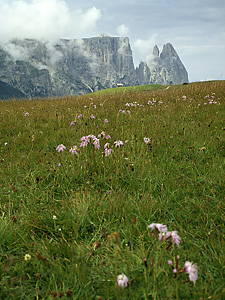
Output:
[{"left": 0, "top": 81, "right": 225, "bottom": 300}]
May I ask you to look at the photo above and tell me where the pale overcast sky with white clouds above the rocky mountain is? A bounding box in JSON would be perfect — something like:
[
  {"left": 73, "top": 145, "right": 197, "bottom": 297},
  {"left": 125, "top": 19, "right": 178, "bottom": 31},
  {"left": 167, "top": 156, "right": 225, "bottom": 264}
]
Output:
[{"left": 0, "top": 0, "right": 225, "bottom": 81}]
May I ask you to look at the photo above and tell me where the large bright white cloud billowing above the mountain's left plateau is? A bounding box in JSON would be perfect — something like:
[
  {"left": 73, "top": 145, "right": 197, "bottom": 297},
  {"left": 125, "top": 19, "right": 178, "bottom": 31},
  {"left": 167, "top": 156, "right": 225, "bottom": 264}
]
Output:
[{"left": 0, "top": 0, "right": 101, "bottom": 40}]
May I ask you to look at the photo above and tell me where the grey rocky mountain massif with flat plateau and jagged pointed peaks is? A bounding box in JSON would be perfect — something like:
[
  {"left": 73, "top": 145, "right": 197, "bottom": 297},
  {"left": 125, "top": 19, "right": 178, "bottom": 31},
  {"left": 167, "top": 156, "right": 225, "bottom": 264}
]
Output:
[{"left": 0, "top": 35, "right": 188, "bottom": 97}]
